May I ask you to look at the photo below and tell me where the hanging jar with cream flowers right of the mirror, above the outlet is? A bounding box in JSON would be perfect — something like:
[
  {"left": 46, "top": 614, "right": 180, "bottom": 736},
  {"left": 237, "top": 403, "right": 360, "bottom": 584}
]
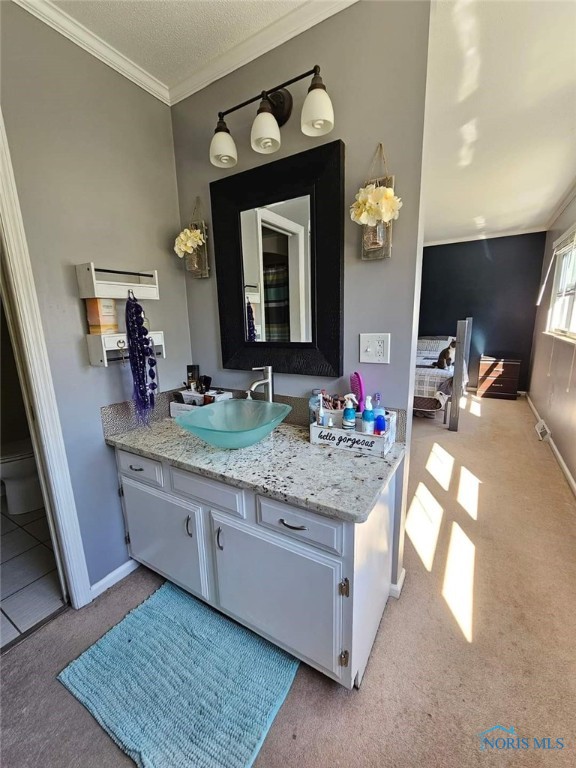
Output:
[{"left": 350, "top": 144, "right": 402, "bottom": 261}]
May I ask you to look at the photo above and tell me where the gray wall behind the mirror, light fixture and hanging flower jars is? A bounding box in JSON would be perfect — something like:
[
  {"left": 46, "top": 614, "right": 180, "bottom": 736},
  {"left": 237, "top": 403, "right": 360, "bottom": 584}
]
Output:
[{"left": 172, "top": 2, "right": 429, "bottom": 408}]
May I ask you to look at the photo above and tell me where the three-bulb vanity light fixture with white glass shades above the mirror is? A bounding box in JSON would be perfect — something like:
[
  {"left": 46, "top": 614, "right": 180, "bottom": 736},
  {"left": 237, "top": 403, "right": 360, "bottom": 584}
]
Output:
[{"left": 210, "top": 65, "right": 334, "bottom": 168}]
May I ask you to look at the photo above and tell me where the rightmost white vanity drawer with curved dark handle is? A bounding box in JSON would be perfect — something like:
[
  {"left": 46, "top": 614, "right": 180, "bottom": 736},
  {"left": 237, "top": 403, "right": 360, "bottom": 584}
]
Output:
[{"left": 256, "top": 496, "right": 344, "bottom": 555}]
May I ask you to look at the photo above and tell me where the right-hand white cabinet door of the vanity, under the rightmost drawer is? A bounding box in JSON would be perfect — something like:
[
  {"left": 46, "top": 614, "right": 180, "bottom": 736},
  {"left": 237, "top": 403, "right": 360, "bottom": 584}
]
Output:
[{"left": 212, "top": 512, "right": 342, "bottom": 675}]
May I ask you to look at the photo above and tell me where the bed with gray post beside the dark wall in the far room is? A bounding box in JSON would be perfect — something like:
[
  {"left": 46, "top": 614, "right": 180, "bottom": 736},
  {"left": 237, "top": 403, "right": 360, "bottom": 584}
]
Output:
[{"left": 414, "top": 317, "right": 472, "bottom": 431}]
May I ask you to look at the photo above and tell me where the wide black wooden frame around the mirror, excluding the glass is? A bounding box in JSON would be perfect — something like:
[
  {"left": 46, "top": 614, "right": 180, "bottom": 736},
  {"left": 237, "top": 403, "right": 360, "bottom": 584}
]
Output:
[{"left": 210, "top": 141, "right": 344, "bottom": 377}]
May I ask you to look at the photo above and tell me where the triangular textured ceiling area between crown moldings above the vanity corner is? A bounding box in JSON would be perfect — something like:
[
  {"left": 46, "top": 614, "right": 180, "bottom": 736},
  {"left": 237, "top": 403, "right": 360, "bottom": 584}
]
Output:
[{"left": 53, "top": 0, "right": 310, "bottom": 88}]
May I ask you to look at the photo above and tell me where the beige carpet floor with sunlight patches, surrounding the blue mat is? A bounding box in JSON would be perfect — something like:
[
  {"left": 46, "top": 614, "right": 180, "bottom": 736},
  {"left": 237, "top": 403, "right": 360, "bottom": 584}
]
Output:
[{"left": 2, "top": 398, "right": 576, "bottom": 768}]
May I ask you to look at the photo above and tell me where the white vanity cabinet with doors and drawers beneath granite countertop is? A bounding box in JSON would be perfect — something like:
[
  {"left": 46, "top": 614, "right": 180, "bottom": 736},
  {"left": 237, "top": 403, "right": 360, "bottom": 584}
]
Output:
[{"left": 117, "top": 449, "right": 394, "bottom": 688}]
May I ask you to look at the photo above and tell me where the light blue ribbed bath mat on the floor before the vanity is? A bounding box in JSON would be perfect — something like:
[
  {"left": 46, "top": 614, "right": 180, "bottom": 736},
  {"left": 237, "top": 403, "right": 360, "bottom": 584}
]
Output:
[{"left": 58, "top": 584, "right": 299, "bottom": 768}]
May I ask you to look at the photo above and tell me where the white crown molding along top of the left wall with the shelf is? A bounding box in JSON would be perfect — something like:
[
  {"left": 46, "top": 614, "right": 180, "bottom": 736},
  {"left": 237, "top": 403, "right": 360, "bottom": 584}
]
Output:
[{"left": 14, "top": 0, "right": 170, "bottom": 105}]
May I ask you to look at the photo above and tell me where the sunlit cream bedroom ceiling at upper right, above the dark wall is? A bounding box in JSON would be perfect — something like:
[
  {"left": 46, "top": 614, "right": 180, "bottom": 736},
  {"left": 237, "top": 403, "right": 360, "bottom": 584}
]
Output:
[{"left": 424, "top": 0, "right": 576, "bottom": 242}]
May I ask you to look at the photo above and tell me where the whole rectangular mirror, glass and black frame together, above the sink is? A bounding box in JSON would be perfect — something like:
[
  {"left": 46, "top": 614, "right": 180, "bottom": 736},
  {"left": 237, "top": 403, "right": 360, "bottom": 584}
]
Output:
[{"left": 210, "top": 141, "right": 344, "bottom": 377}]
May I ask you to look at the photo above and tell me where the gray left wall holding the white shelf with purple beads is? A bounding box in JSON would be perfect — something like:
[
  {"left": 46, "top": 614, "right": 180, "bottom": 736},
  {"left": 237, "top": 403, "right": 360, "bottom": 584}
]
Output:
[{"left": 0, "top": 2, "right": 190, "bottom": 583}]
